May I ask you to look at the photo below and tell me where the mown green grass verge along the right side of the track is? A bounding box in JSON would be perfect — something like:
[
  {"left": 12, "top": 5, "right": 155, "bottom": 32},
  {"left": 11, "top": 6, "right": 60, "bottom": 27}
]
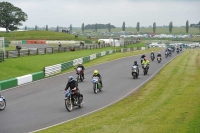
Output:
[{"left": 36, "top": 49, "right": 200, "bottom": 133}]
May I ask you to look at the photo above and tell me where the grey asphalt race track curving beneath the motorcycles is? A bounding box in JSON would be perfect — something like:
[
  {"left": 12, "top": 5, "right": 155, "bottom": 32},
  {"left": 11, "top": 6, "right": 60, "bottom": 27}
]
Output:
[{"left": 0, "top": 51, "right": 181, "bottom": 133}]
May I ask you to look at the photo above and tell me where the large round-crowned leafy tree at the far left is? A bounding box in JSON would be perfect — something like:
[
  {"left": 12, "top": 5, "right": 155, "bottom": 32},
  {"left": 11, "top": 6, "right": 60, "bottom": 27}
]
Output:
[{"left": 0, "top": 2, "right": 28, "bottom": 32}]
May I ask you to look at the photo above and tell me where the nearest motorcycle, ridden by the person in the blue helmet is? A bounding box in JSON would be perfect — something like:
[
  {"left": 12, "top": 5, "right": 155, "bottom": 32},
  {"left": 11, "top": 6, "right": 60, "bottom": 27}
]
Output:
[{"left": 65, "top": 90, "right": 83, "bottom": 112}]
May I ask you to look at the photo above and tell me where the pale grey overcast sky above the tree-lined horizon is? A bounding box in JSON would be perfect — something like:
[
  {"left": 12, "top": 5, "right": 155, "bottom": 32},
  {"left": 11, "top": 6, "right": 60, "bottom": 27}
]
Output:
[{"left": 3, "top": 0, "right": 200, "bottom": 27}]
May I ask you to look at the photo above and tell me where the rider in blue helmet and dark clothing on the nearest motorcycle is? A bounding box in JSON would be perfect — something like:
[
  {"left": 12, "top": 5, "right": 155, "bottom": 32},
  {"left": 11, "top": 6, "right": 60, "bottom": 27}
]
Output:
[{"left": 65, "top": 76, "right": 82, "bottom": 102}]
